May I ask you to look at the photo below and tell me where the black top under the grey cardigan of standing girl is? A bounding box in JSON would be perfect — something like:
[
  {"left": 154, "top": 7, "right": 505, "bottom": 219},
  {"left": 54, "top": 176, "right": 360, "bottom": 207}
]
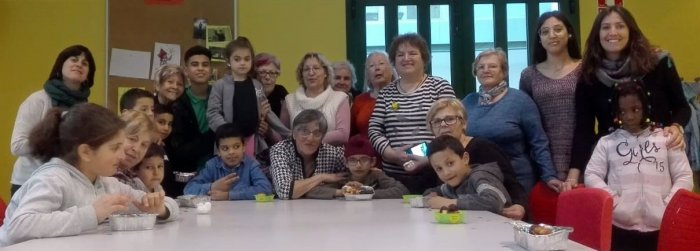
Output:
[{"left": 231, "top": 78, "right": 260, "bottom": 137}]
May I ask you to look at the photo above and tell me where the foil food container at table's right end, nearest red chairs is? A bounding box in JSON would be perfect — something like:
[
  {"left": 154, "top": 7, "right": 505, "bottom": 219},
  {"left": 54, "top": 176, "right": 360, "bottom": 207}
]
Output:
[{"left": 512, "top": 221, "right": 574, "bottom": 251}]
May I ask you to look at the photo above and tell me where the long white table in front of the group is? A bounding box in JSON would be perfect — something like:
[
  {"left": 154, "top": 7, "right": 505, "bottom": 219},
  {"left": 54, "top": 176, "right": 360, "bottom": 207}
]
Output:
[{"left": 4, "top": 200, "right": 592, "bottom": 251}]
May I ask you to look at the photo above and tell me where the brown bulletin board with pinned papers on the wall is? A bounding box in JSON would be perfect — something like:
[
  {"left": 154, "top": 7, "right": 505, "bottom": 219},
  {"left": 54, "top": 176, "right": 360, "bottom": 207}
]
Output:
[{"left": 106, "top": 0, "right": 236, "bottom": 111}]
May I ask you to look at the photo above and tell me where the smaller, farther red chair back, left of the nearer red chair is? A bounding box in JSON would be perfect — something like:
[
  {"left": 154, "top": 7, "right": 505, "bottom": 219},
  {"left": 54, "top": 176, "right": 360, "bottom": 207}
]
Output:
[{"left": 527, "top": 181, "right": 559, "bottom": 225}]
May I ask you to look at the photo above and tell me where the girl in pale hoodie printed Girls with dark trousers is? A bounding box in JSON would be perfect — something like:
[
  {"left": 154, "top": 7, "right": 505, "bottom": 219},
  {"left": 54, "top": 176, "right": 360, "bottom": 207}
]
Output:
[{"left": 584, "top": 82, "right": 693, "bottom": 250}]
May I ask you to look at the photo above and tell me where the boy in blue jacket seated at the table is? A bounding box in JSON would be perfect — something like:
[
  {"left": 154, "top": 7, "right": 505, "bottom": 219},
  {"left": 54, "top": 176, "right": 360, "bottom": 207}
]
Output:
[{"left": 185, "top": 123, "right": 272, "bottom": 200}]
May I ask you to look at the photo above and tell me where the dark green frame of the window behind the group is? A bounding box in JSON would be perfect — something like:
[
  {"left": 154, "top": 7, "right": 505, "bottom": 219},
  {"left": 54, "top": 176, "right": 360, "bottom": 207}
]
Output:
[{"left": 345, "top": 0, "right": 581, "bottom": 98}]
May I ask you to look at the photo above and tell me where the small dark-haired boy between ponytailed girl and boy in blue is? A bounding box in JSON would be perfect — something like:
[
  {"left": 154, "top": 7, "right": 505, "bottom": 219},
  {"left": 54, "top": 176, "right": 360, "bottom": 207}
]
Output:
[{"left": 132, "top": 144, "right": 165, "bottom": 193}]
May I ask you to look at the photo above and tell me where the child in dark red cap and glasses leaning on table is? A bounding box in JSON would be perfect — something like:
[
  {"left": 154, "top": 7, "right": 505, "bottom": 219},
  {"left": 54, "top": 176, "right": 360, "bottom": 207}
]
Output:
[{"left": 305, "top": 135, "right": 408, "bottom": 199}]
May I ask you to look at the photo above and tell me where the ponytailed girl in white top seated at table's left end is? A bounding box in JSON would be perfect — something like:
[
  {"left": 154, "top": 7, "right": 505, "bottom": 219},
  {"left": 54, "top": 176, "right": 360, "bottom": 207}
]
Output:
[{"left": 0, "top": 103, "right": 179, "bottom": 246}]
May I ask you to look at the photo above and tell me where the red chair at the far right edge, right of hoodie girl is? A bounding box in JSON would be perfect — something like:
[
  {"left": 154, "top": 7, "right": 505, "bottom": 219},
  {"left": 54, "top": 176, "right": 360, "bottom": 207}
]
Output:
[{"left": 658, "top": 189, "right": 700, "bottom": 251}]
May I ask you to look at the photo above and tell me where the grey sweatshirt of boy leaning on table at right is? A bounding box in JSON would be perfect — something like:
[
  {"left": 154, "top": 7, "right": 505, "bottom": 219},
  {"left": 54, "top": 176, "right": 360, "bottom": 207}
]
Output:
[{"left": 425, "top": 162, "right": 511, "bottom": 214}]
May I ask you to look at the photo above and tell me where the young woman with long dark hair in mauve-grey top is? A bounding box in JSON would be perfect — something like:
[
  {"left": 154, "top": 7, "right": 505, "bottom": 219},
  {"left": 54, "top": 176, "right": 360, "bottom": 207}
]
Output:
[{"left": 520, "top": 11, "right": 584, "bottom": 192}]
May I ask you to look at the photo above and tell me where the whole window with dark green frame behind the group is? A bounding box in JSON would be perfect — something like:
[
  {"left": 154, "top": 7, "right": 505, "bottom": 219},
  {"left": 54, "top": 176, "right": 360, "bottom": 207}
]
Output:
[{"left": 346, "top": 0, "right": 579, "bottom": 97}]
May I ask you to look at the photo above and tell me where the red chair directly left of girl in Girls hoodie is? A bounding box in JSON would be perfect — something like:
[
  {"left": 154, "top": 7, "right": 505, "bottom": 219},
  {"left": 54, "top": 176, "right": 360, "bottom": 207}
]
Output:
[{"left": 556, "top": 188, "right": 613, "bottom": 251}]
